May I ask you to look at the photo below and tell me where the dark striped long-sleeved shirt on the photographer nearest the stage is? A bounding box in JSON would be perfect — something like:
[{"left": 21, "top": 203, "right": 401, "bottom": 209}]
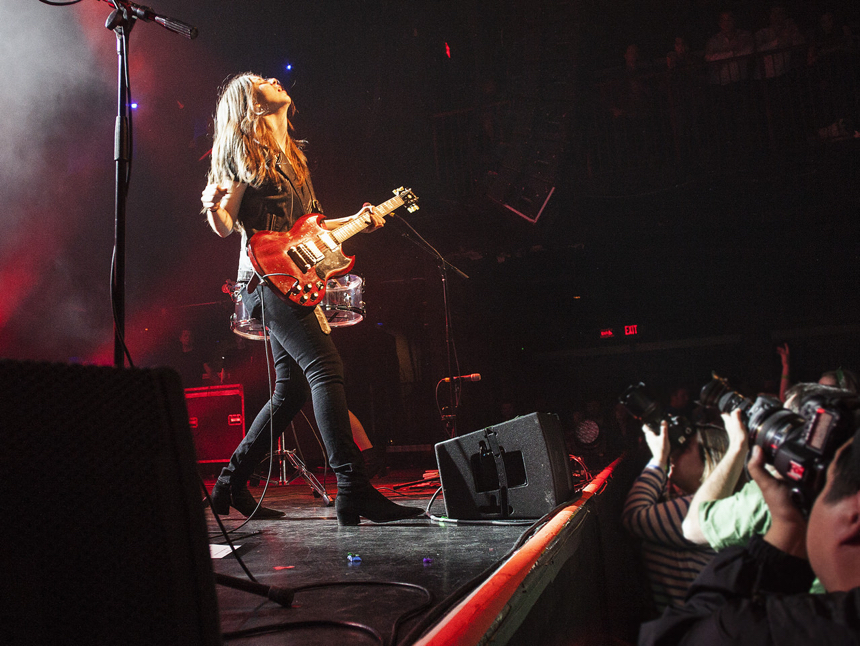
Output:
[{"left": 622, "top": 465, "right": 715, "bottom": 612}]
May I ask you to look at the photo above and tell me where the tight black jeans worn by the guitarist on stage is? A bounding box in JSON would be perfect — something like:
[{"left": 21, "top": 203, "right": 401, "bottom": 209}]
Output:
[{"left": 218, "top": 284, "right": 368, "bottom": 491}]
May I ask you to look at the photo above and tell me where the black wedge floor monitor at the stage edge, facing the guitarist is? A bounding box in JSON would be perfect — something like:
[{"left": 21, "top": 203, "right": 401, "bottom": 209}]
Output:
[{"left": 436, "top": 413, "right": 572, "bottom": 520}]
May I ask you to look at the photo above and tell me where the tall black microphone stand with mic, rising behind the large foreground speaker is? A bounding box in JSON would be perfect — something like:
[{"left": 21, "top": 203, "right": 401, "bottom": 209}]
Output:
[{"left": 104, "top": 0, "right": 197, "bottom": 368}]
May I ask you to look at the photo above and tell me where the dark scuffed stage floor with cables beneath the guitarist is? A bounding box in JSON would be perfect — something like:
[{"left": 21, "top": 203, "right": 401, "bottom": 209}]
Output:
[{"left": 205, "top": 469, "right": 529, "bottom": 646}]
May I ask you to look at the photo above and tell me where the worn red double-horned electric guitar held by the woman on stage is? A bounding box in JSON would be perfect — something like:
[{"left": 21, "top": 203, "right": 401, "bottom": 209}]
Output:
[{"left": 248, "top": 187, "right": 418, "bottom": 307}]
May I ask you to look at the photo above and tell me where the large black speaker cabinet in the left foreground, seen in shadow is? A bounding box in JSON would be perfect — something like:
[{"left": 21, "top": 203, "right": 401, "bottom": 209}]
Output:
[{"left": 0, "top": 360, "right": 221, "bottom": 646}]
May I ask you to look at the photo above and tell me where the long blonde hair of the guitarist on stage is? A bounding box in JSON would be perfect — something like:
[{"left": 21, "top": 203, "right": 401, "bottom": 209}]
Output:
[{"left": 208, "top": 72, "right": 309, "bottom": 188}]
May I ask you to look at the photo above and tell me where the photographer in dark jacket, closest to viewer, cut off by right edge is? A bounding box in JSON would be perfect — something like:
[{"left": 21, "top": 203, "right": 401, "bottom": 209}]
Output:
[{"left": 639, "top": 428, "right": 860, "bottom": 645}]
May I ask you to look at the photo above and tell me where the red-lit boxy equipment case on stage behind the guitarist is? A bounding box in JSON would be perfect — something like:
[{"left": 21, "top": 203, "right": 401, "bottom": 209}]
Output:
[{"left": 185, "top": 384, "right": 245, "bottom": 462}]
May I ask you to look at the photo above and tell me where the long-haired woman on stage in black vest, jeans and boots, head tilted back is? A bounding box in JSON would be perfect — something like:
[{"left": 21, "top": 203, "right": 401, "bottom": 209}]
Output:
[{"left": 201, "top": 73, "right": 422, "bottom": 525}]
